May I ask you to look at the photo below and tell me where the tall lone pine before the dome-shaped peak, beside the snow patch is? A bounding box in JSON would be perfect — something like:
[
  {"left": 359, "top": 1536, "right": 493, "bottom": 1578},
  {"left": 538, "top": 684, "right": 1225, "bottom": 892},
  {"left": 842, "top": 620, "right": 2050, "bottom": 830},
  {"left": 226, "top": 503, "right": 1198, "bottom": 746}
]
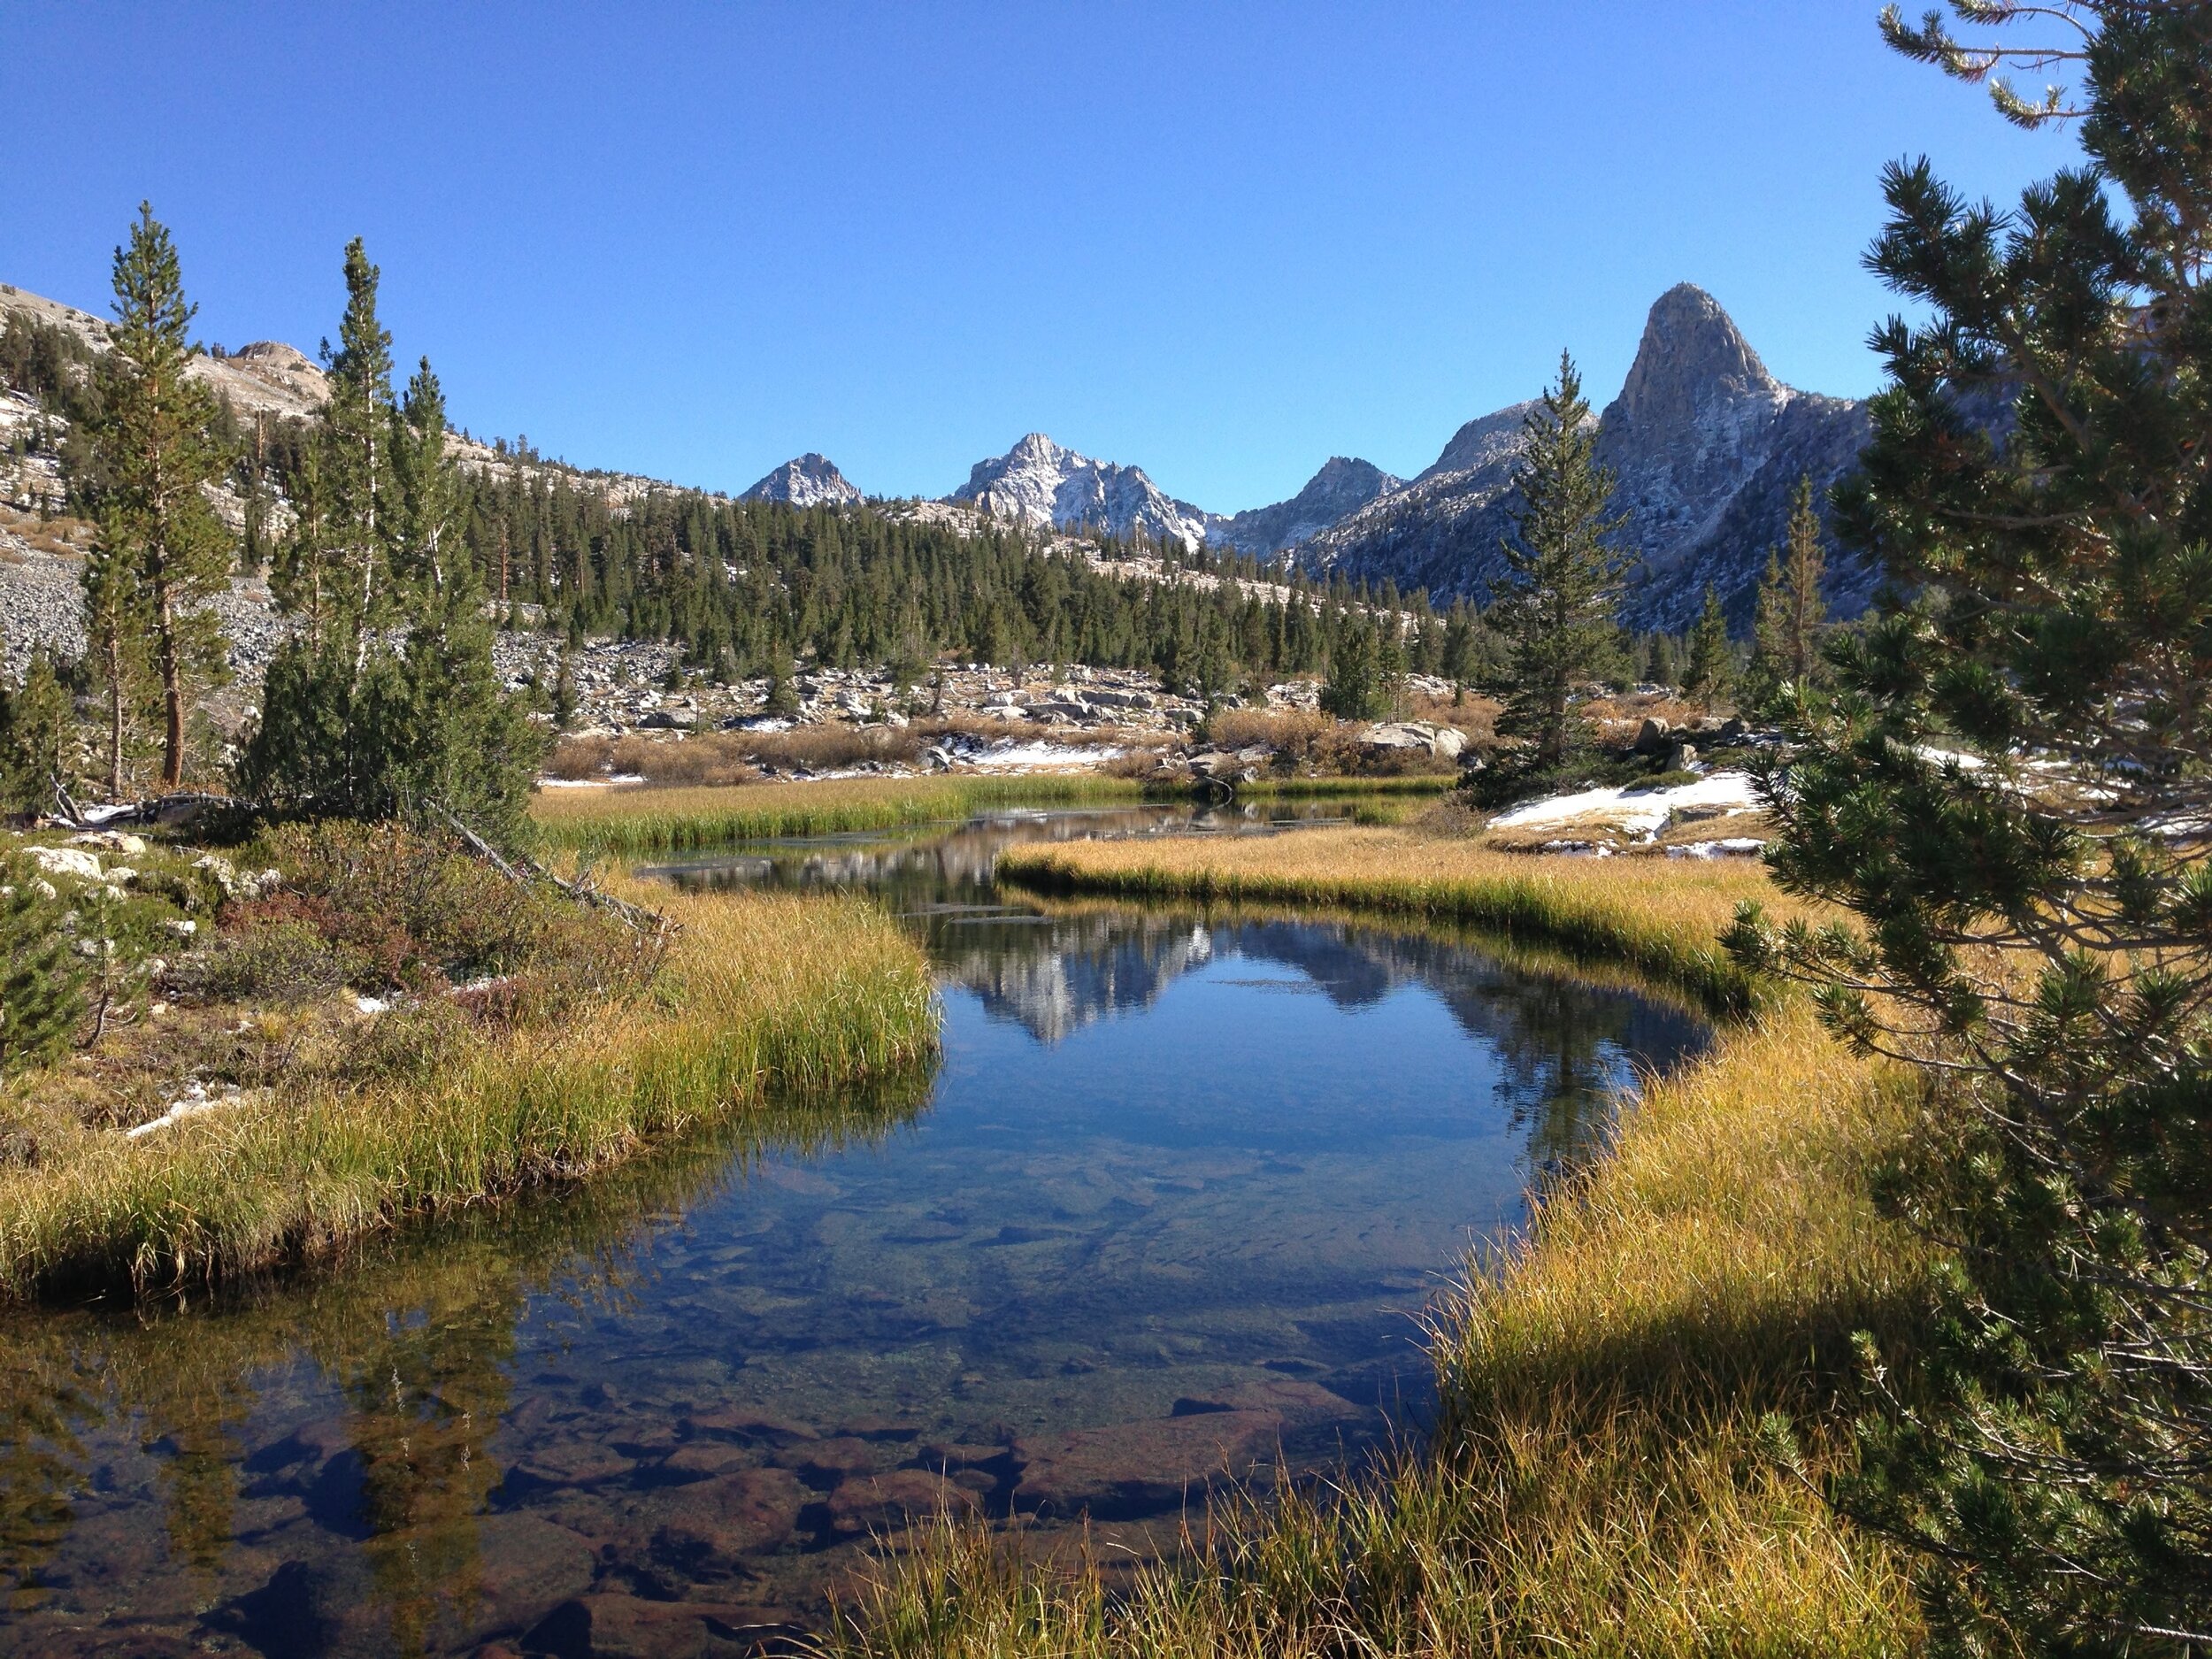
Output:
[{"left": 1489, "top": 352, "right": 1637, "bottom": 777}]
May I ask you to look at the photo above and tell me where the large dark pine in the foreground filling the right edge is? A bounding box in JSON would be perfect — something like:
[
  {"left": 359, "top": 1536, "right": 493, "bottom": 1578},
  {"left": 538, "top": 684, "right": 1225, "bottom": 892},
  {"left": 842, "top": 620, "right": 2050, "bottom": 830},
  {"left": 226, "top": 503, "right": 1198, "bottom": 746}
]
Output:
[{"left": 1730, "top": 0, "right": 2212, "bottom": 1655}]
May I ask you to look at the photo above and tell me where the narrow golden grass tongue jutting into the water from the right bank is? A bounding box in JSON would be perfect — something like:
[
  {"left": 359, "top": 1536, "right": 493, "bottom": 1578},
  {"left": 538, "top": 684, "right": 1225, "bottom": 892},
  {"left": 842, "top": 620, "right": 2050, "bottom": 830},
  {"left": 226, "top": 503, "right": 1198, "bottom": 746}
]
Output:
[{"left": 998, "top": 830, "right": 1786, "bottom": 1007}]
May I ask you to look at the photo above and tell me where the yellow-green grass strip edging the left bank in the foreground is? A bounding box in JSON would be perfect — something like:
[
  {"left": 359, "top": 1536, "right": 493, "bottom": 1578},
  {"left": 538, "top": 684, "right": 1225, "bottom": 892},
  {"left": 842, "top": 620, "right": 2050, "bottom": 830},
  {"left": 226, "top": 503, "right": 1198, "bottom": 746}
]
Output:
[{"left": 0, "top": 896, "right": 936, "bottom": 1296}]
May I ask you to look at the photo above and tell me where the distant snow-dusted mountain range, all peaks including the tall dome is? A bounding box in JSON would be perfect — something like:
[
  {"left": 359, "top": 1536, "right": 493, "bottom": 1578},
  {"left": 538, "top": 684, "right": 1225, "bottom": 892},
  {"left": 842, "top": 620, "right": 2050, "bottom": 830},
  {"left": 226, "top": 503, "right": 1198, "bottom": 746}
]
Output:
[{"left": 746, "top": 283, "right": 1878, "bottom": 631}]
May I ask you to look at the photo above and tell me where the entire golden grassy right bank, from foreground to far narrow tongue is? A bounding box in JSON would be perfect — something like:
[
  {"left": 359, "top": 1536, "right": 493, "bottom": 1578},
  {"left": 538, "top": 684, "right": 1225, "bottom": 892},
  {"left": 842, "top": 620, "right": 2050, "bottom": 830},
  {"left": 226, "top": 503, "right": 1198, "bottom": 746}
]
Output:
[{"left": 839, "top": 845, "right": 1924, "bottom": 1659}]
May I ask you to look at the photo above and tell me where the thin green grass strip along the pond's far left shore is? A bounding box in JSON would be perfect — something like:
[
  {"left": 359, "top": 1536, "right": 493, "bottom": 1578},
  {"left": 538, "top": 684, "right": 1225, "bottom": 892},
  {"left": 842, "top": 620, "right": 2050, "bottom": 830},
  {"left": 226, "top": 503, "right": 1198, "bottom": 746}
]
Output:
[{"left": 531, "top": 772, "right": 1144, "bottom": 854}]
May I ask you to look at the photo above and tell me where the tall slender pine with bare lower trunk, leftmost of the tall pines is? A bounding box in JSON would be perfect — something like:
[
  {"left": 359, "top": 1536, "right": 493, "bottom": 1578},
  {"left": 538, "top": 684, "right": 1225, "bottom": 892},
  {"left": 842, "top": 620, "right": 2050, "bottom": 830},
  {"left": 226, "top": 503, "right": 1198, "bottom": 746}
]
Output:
[{"left": 87, "top": 202, "right": 233, "bottom": 792}]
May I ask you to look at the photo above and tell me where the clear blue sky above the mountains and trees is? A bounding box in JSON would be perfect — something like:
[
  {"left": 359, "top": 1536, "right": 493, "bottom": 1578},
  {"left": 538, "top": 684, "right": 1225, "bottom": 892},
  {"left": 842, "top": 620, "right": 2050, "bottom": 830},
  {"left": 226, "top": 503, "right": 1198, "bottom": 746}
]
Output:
[{"left": 0, "top": 0, "right": 2070, "bottom": 511}]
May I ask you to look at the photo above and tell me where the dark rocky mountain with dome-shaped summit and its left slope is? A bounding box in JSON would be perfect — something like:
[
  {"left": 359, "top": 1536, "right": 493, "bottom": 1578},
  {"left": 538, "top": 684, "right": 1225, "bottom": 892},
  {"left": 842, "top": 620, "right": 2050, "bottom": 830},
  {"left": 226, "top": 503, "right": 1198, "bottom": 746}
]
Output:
[{"left": 1301, "top": 283, "right": 1876, "bottom": 628}]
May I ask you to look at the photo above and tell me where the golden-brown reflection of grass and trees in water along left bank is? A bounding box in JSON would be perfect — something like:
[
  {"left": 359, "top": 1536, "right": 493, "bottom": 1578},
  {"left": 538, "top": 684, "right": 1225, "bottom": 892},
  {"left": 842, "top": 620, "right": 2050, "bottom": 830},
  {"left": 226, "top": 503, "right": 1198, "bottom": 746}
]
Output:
[{"left": 0, "top": 1073, "right": 932, "bottom": 1653}]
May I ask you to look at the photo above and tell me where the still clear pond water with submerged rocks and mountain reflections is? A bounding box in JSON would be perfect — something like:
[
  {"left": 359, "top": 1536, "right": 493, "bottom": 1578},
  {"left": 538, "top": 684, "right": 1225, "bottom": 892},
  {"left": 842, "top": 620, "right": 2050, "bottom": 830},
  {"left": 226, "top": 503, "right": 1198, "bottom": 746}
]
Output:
[{"left": 0, "top": 814, "right": 1701, "bottom": 1659}]
